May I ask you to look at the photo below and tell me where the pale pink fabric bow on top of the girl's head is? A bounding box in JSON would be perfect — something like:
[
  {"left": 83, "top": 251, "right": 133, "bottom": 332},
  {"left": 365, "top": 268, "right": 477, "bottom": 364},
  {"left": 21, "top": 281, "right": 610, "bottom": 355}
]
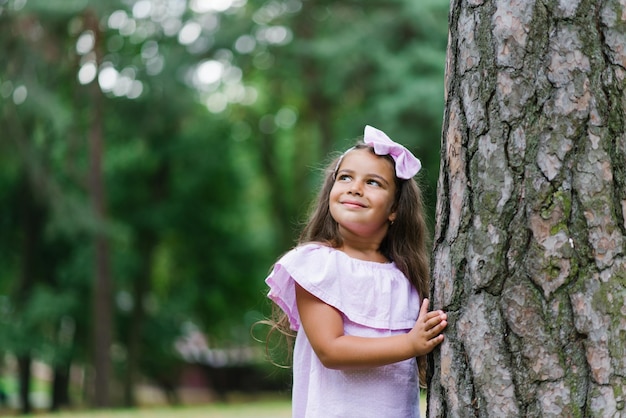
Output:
[{"left": 363, "top": 125, "right": 422, "bottom": 180}]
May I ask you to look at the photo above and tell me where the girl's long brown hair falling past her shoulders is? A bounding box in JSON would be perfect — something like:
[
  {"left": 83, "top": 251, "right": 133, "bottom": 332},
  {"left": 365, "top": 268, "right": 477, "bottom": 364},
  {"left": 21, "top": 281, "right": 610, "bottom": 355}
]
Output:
[{"left": 266, "top": 142, "right": 430, "bottom": 386}]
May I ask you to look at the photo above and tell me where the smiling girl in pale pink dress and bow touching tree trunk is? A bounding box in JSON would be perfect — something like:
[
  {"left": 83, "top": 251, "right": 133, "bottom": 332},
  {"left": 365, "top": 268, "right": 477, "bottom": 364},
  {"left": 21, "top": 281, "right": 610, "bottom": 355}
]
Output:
[{"left": 266, "top": 126, "right": 447, "bottom": 418}]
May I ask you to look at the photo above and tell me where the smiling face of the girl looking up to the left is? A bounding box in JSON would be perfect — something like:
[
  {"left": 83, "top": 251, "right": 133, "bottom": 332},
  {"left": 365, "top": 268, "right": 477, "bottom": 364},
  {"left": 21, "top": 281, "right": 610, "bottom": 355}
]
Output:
[{"left": 329, "top": 149, "right": 396, "bottom": 240}]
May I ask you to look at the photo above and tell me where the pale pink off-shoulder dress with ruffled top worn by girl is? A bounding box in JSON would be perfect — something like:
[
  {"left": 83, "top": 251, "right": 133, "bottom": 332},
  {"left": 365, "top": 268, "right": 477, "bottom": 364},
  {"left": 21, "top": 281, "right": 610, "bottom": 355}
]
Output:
[{"left": 265, "top": 244, "right": 420, "bottom": 418}]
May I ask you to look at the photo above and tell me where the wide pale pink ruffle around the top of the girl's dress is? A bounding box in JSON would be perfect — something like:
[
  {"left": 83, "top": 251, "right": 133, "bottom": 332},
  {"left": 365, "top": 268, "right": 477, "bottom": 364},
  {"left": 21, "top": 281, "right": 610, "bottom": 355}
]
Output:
[{"left": 265, "top": 244, "right": 420, "bottom": 331}]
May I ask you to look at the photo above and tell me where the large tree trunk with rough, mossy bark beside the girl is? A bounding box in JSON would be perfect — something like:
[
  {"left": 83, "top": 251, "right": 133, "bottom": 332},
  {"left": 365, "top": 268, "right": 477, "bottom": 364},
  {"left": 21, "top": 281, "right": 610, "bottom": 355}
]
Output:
[{"left": 428, "top": 0, "right": 626, "bottom": 417}]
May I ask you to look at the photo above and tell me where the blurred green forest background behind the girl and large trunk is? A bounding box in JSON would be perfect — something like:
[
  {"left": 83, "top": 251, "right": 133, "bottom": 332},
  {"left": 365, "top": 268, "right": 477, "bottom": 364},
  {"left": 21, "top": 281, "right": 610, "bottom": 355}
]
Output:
[{"left": 0, "top": 0, "right": 449, "bottom": 412}]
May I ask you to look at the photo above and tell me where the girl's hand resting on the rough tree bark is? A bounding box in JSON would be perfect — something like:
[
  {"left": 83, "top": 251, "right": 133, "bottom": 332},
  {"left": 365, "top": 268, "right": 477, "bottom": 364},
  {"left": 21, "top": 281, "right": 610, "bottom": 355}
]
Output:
[{"left": 407, "top": 299, "right": 448, "bottom": 357}]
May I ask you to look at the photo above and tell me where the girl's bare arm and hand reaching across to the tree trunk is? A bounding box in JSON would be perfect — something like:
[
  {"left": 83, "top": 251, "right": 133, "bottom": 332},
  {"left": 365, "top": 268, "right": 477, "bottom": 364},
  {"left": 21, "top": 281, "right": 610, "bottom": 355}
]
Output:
[{"left": 296, "top": 284, "right": 447, "bottom": 369}]
